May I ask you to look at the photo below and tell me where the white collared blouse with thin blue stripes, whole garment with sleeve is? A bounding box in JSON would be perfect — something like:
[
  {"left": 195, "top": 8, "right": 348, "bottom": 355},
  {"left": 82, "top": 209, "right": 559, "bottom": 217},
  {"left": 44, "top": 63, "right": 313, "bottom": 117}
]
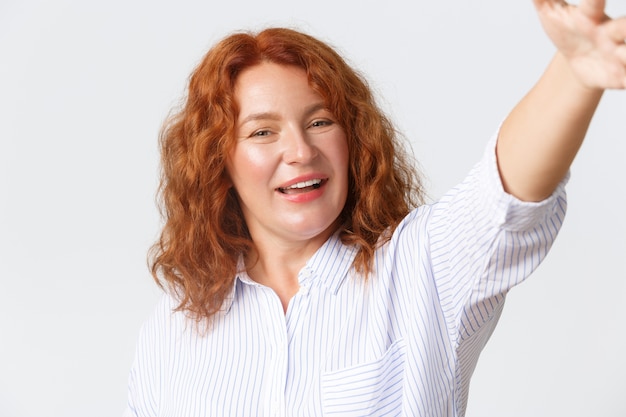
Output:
[{"left": 126, "top": 132, "right": 566, "bottom": 417}]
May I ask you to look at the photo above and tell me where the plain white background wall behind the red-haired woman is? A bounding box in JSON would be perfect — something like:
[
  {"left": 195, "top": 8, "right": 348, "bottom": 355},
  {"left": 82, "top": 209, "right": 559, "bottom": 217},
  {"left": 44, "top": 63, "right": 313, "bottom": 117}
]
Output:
[{"left": 0, "top": 0, "right": 626, "bottom": 417}]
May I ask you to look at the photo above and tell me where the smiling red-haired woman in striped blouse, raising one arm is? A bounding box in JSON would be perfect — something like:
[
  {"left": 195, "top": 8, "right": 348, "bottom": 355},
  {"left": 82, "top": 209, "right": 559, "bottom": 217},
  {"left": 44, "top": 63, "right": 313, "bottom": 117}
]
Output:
[{"left": 128, "top": 0, "right": 626, "bottom": 416}]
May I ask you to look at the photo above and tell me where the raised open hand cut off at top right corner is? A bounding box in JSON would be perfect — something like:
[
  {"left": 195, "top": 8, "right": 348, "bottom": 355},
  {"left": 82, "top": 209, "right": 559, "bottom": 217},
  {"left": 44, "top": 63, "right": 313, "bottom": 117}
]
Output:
[{"left": 533, "top": 0, "right": 626, "bottom": 89}]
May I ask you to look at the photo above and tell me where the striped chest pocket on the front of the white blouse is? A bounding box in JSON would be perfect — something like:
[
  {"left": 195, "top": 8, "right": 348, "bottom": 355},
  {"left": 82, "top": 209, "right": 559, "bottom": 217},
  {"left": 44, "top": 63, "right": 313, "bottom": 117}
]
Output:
[{"left": 321, "top": 339, "right": 406, "bottom": 417}]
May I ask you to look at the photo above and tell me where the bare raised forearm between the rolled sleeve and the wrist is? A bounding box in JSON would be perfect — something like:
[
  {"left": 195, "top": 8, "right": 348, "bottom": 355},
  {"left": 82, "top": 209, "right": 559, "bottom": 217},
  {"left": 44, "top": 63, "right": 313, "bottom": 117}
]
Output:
[{"left": 496, "top": 53, "right": 603, "bottom": 201}]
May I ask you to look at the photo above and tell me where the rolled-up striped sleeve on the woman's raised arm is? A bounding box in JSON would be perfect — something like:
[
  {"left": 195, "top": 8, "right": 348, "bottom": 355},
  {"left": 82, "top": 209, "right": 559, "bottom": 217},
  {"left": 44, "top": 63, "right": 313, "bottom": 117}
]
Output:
[{"left": 429, "top": 131, "right": 568, "bottom": 410}]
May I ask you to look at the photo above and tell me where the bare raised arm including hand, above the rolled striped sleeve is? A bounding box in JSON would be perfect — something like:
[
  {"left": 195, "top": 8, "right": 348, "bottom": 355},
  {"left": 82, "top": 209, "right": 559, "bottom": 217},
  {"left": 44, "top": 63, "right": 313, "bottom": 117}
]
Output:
[{"left": 496, "top": 0, "right": 626, "bottom": 201}]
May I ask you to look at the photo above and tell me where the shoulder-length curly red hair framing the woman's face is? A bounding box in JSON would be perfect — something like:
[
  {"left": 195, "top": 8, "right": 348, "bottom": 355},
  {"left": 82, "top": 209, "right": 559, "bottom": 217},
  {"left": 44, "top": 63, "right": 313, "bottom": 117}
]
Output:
[{"left": 150, "top": 28, "right": 423, "bottom": 320}]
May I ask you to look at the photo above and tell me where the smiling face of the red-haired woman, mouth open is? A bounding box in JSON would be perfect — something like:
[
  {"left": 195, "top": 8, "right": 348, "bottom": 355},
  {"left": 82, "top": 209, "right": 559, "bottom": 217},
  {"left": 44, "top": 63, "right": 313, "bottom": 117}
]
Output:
[{"left": 227, "top": 63, "right": 348, "bottom": 246}]
